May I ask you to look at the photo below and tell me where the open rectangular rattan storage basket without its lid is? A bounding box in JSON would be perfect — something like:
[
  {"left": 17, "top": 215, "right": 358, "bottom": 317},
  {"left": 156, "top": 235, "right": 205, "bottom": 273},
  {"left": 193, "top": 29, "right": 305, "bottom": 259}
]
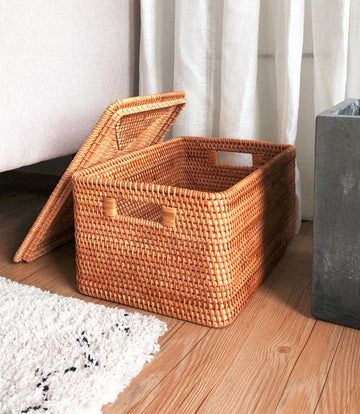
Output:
[{"left": 72, "top": 130, "right": 295, "bottom": 327}]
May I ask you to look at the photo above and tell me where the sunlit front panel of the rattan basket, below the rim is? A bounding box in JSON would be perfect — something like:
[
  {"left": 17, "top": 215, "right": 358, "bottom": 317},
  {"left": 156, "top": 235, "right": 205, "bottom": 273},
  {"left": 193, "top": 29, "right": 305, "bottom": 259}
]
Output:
[{"left": 74, "top": 175, "right": 236, "bottom": 326}]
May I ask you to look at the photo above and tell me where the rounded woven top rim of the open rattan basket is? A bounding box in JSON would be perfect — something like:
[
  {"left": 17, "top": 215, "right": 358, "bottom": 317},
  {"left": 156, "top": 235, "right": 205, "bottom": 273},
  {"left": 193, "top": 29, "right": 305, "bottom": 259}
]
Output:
[{"left": 72, "top": 136, "right": 296, "bottom": 201}]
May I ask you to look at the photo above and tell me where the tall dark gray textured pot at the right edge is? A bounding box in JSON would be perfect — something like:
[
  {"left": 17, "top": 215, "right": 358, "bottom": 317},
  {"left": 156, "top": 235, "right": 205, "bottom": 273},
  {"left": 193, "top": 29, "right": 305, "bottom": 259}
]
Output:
[{"left": 312, "top": 99, "right": 360, "bottom": 328}]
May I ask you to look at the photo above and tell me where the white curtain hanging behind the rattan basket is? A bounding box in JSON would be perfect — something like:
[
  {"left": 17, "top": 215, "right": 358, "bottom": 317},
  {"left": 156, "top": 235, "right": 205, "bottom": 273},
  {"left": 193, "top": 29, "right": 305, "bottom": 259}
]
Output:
[{"left": 140, "top": 0, "right": 360, "bottom": 219}]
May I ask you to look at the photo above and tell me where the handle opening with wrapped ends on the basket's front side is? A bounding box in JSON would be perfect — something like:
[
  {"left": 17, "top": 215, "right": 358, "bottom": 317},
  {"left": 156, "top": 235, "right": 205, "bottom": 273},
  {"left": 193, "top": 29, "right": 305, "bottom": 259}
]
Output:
[{"left": 103, "top": 197, "right": 176, "bottom": 227}]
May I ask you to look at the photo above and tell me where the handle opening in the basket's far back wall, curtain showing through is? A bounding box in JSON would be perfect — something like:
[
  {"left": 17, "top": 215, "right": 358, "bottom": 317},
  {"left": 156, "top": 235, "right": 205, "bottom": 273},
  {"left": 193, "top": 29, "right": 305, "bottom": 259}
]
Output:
[{"left": 209, "top": 150, "right": 264, "bottom": 167}]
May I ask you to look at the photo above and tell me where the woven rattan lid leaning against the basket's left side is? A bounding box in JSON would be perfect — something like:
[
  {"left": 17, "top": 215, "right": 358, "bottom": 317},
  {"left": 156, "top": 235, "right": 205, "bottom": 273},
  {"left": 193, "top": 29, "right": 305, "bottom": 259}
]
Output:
[{"left": 14, "top": 92, "right": 185, "bottom": 262}]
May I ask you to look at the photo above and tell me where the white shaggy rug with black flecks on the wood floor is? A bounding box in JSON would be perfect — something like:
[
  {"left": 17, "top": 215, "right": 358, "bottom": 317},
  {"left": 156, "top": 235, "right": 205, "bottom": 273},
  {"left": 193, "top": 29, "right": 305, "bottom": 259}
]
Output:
[{"left": 0, "top": 277, "right": 166, "bottom": 414}]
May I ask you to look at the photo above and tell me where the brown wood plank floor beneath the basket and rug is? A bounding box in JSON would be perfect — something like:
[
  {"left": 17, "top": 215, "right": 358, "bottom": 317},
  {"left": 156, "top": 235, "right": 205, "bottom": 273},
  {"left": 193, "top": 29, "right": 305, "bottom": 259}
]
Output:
[{"left": 0, "top": 179, "right": 360, "bottom": 414}]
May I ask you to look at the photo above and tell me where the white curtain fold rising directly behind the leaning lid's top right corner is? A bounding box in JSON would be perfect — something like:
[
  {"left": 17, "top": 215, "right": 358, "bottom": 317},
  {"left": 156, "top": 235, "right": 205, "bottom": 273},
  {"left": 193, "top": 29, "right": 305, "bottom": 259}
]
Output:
[{"left": 174, "top": 0, "right": 216, "bottom": 135}]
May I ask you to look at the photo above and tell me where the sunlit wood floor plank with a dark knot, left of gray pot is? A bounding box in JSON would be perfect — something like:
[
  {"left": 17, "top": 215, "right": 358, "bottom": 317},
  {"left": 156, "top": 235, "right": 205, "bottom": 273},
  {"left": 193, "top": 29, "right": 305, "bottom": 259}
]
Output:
[{"left": 198, "top": 292, "right": 314, "bottom": 414}]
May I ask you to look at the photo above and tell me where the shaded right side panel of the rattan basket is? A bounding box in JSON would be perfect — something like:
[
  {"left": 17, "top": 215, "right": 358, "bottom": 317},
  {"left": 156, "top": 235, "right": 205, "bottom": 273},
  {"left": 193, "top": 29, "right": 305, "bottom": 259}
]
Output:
[{"left": 231, "top": 146, "right": 295, "bottom": 309}]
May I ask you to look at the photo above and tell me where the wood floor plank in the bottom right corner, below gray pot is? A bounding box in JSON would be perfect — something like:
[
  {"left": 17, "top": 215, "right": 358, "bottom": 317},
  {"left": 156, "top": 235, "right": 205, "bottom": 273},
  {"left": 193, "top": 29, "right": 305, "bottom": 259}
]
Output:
[{"left": 315, "top": 327, "right": 360, "bottom": 414}]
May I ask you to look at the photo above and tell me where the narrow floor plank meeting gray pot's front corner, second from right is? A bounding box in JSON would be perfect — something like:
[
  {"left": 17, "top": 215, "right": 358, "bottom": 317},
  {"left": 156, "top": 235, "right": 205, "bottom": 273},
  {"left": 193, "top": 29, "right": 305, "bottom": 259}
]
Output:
[{"left": 275, "top": 321, "right": 343, "bottom": 414}]
